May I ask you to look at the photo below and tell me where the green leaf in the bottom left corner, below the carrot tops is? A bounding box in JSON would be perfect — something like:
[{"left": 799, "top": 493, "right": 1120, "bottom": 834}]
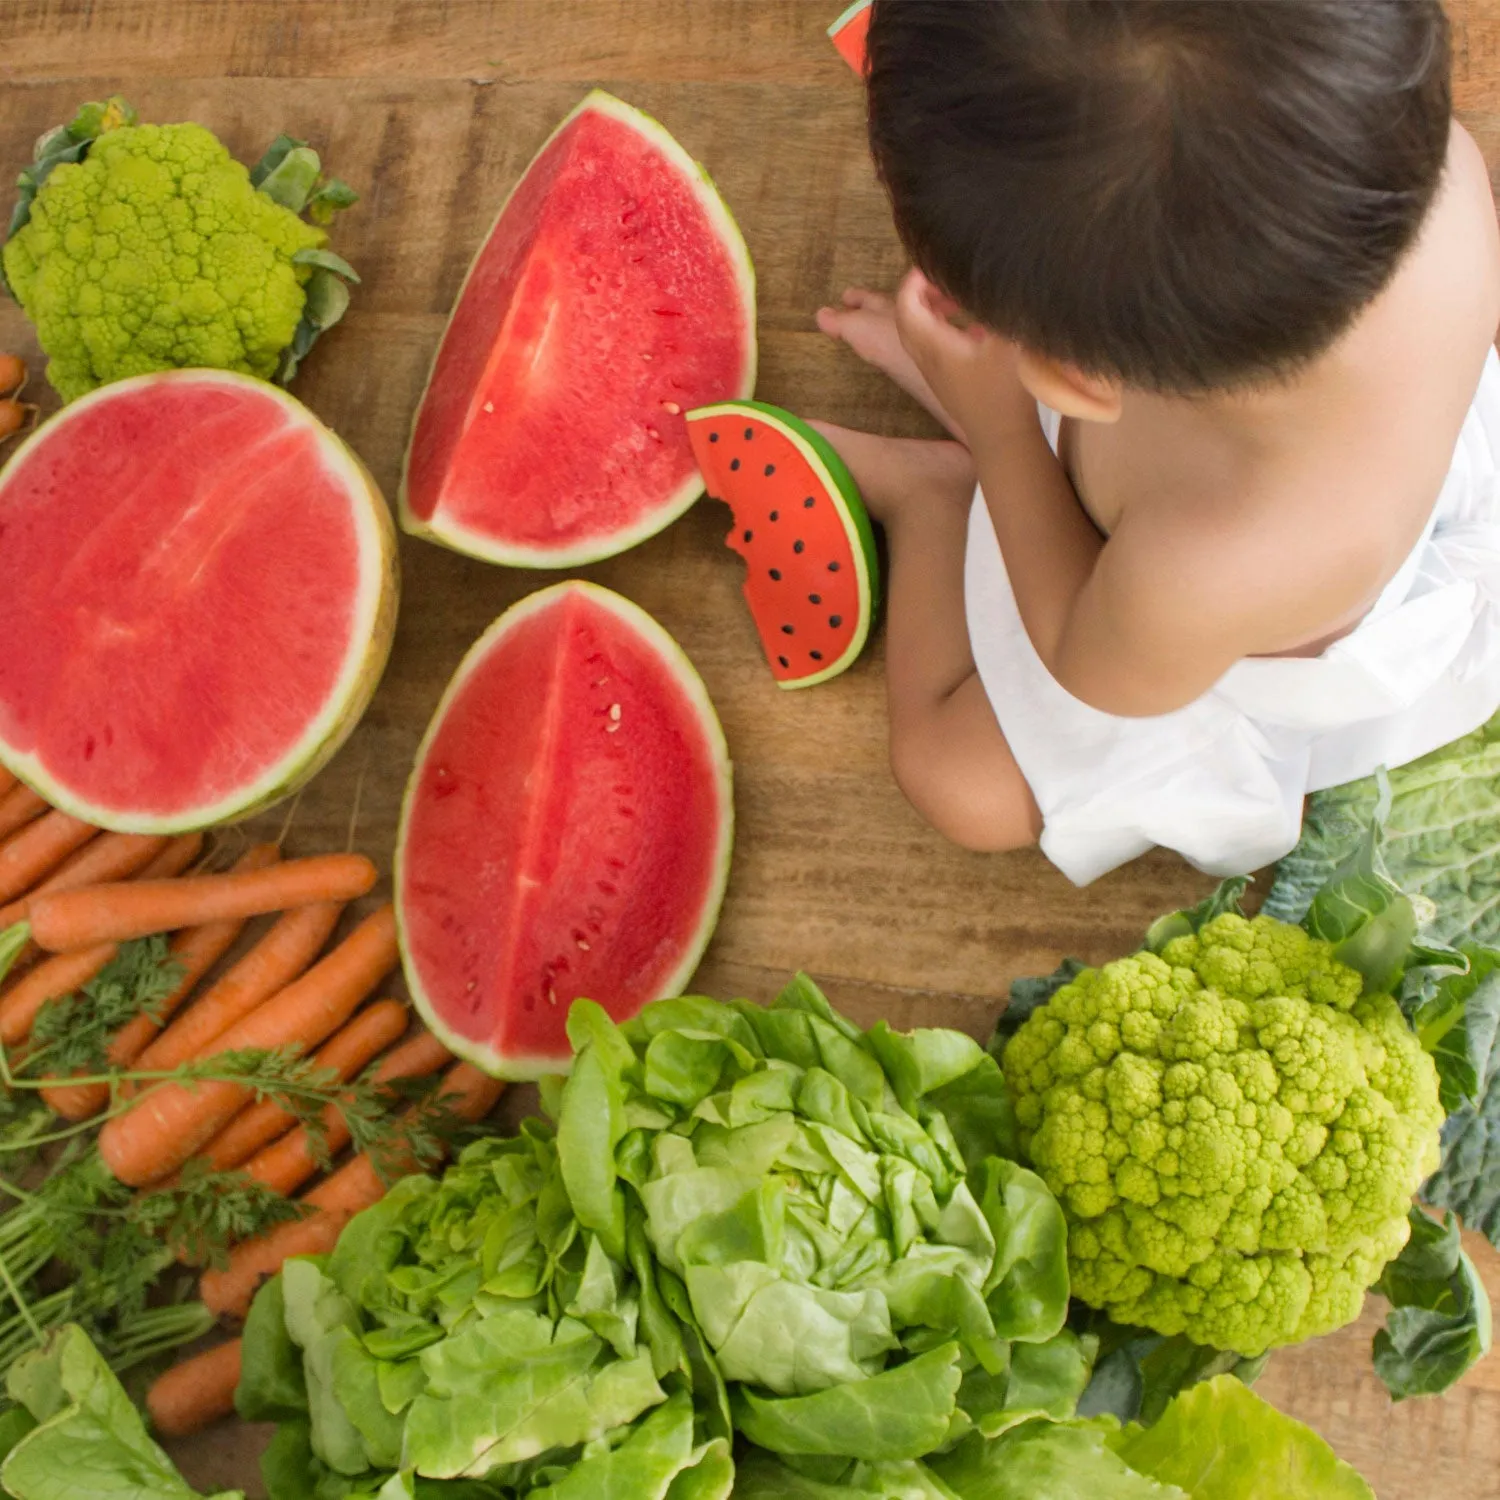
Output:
[{"left": 0, "top": 1326, "right": 237, "bottom": 1500}]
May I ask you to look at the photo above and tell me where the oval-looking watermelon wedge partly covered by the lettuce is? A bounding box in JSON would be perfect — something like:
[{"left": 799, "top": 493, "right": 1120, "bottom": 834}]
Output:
[{"left": 396, "top": 582, "right": 734, "bottom": 1079}]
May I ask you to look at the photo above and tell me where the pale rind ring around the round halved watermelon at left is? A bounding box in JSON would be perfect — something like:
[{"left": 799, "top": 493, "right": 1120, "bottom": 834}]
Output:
[{"left": 0, "top": 369, "right": 401, "bottom": 834}]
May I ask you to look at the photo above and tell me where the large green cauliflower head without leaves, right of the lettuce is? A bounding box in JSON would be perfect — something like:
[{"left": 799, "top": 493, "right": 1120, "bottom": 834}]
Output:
[{"left": 1004, "top": 915, "right": 1443, "bottom": 1358}]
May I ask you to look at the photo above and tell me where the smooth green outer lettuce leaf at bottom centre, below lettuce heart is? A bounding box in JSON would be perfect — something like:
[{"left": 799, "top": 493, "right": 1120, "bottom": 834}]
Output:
[{"left": 732, "top": 1344, "right": 960, "bottom": 1461}]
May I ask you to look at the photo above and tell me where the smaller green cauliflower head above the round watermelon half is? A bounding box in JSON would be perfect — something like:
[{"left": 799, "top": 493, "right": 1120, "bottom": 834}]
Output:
[{"left": 3, "top": 125, "right": 327, "bottom": 401}]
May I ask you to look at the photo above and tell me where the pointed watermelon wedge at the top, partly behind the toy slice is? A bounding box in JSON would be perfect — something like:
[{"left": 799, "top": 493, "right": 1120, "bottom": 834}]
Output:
[{"left": 399, "top": 90, "right": 756, "bottom": 567}]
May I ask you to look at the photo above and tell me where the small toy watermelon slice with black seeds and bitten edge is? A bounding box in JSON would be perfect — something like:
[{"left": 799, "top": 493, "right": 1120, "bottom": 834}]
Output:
[{"left": 687, "top": 401, "right": 881, "bottom": 687}]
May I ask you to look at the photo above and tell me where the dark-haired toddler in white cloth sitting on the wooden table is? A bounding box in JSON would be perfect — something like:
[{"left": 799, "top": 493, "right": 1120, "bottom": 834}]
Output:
[{"left": 819, "top": 0, "right": 1500, "bottom": 884}]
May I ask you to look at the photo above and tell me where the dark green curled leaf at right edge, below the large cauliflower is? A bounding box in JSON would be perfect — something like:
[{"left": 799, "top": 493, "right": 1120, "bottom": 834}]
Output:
[{"left": 1374, "top": 1206, "right": 1491, "bottom": 1401}]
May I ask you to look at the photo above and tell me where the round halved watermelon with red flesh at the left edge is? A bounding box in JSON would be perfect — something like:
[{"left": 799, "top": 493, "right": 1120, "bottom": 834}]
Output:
[{"left": 0, "top": 371, "right": 396, "bottom": 834}]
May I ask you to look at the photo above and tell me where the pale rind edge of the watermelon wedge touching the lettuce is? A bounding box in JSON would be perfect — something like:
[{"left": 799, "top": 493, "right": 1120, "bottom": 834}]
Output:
[{"left": 393, "top": 579, "right": 735, "bottom": 1083}]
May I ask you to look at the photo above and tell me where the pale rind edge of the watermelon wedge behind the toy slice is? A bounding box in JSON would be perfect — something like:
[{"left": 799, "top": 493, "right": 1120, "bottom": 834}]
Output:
[{"left": 396, "top": 89, "right": 759, "bottom": 569}]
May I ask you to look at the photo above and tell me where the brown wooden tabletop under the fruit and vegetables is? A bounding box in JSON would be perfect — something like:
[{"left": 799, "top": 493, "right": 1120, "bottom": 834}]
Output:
[{"left": 0, "top": 0, "right": 1500, "bottom": 1500}]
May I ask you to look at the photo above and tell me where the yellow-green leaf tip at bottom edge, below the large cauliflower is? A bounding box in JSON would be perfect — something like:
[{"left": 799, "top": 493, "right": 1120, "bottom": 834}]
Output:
[{"left": 1106, "top": 1376, "right": 1374, "bottom": 1500}]
